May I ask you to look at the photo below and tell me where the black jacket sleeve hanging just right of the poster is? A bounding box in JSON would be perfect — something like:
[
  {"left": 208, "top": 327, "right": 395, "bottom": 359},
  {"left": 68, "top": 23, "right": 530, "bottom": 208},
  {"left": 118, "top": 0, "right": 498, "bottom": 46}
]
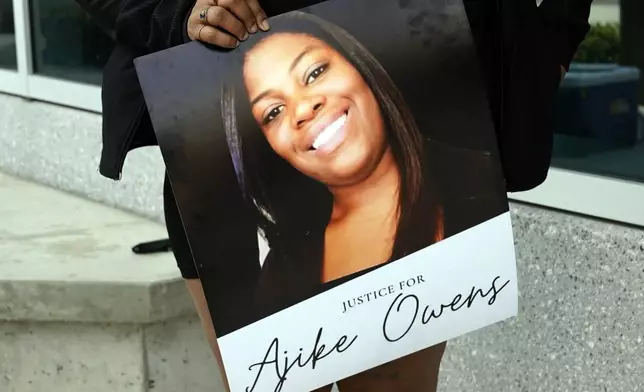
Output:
[{"left": 478, "top": 0, "right": 592, "bottom": 192}]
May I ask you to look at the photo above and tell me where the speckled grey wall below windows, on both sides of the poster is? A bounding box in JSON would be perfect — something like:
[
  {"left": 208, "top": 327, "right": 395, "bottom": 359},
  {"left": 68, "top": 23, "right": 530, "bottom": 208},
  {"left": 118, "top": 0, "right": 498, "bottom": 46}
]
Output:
[{"left": 0, "top": 72, "right": 644, "bottom": 392}]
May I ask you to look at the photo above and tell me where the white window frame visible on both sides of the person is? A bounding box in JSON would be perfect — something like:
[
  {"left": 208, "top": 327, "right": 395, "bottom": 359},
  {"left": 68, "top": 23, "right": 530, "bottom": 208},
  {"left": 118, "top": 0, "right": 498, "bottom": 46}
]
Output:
[{"left": 0, "top": 0, "right": 644, "bottom": 227}]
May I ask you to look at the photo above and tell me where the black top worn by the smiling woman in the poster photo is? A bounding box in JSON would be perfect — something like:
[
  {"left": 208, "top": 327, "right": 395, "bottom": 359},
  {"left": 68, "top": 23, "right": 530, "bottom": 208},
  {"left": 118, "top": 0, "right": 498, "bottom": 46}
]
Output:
[{"left": 249, "top": 141, "right": 508, "bottom": 321}]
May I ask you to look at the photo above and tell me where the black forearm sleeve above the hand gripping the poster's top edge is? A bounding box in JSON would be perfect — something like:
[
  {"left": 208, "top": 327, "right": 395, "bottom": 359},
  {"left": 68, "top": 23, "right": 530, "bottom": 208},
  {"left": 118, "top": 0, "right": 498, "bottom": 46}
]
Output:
[{"left": 76, "top": 0, "right": 194, "bottom": 53}]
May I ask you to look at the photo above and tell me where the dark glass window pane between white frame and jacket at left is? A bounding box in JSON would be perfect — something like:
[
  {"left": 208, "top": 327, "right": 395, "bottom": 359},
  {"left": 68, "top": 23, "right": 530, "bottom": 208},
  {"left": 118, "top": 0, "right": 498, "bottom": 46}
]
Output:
[{"left": 31, "top": 0, "right": 113, "bottom": 85}]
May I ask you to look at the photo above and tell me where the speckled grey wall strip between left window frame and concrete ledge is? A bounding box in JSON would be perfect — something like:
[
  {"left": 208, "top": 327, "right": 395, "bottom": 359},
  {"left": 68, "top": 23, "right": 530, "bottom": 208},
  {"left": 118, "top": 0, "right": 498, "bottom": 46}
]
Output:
[{"left": 0, "top": 94, "right": 164, "bottom": 220}]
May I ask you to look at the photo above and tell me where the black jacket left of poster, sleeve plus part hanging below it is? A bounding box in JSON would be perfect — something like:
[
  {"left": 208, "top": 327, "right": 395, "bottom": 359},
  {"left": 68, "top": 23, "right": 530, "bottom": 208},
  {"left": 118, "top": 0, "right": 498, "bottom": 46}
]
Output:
[{"left": 76, "top": 0, "right": 195, "bottom": 180}]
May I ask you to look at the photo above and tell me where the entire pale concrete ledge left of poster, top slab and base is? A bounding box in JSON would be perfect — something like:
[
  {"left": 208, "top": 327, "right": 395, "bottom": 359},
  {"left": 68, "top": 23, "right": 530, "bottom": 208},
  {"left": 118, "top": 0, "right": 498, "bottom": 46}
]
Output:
[{"left": 0, "top": 173, "right": 221, "bottom": 392}]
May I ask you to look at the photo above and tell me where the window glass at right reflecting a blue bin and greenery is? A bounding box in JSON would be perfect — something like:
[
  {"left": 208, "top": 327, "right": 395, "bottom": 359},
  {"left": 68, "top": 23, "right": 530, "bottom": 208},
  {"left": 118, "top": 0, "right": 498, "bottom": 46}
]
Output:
[{"left": 553, "top": 0, "right": 644, "bottom": 182}]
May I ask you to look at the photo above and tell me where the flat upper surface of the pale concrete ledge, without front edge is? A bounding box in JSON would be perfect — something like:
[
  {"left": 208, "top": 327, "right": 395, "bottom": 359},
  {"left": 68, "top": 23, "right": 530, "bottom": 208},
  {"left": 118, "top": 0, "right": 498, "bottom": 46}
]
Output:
[{"left": 0, "top": 173, "right": 178, "bottom": 283}]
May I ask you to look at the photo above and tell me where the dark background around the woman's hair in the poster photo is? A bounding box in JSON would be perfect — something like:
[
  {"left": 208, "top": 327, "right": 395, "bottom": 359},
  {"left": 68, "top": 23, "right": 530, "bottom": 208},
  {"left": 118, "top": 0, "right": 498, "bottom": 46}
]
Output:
[{"left": 136, "top": 0, "right": 505, "bottom": 337}]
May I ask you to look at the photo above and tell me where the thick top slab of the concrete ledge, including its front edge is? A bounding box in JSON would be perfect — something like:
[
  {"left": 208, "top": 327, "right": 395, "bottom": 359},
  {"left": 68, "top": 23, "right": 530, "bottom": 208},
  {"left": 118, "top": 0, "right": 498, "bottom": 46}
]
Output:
[{"left": 0, "top": 173, "right": 190, "bottom": 322}]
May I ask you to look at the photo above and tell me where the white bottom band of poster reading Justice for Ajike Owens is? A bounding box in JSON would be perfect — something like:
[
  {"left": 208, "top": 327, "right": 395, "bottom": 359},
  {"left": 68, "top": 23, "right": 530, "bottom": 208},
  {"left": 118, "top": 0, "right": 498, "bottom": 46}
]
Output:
[{"left": 219, "top": 212, "right": 518, "bottom": 392}]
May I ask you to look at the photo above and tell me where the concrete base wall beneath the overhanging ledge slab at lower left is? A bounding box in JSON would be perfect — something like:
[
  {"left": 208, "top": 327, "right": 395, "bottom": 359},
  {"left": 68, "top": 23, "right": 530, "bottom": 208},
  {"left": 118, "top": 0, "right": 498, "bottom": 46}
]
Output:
[{"left": 0, "top": 317, "right": 223, "bottom": 392}]
